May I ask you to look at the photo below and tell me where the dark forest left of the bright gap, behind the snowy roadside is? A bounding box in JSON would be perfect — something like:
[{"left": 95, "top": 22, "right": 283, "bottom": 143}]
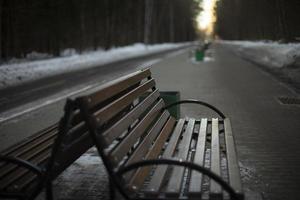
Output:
[{"left": 0, "top": 0, "right": 198, "bottom": 60}]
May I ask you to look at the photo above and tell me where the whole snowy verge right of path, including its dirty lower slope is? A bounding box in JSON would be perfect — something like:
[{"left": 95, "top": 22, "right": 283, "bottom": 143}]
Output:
[{"left": 218, "top": 41, "right": 300, "bottom": 91}]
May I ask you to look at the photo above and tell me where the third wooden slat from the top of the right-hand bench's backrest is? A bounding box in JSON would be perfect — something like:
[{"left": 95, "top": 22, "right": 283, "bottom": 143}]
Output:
[{"left": 101, "top": 90, "right": 159, "bottom": 145}]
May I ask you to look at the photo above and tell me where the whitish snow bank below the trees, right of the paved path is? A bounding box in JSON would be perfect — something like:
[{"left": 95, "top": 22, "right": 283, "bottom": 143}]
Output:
[{"left": 221, "top": 41, "right": 300, "bottom": 68}]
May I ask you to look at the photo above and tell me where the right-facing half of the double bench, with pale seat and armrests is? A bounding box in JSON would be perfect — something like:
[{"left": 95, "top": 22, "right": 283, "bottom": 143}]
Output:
[{"left": 74, "top": 70, "right": 244, "bottom": 199}]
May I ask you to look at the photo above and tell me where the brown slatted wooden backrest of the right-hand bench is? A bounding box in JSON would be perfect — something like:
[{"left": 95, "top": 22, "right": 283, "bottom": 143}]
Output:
[{"left": 77, "top": 70, "right": 175, "bottom": 188}]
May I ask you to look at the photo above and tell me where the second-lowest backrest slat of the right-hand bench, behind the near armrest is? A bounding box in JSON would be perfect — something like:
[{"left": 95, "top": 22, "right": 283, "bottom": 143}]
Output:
[{"left": 125, "top": 111, "right": 170, "bottom": 180}]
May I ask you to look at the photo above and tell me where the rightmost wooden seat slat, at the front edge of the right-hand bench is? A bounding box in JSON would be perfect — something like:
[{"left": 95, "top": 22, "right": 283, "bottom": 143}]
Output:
[{"left": 224, "top": 118, "right": 243, "bottom": 197}]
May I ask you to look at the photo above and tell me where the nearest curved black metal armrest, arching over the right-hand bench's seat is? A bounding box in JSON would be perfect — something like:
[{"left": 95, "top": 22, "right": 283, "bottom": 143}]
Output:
[{"left": 116, "top": 159, "right": 239, "bottom": 200}]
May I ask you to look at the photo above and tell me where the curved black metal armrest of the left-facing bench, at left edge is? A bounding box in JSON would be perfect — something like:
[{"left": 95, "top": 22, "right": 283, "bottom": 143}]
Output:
[{"left": 0, "top": 155, "right": 43, "bottom": 176}]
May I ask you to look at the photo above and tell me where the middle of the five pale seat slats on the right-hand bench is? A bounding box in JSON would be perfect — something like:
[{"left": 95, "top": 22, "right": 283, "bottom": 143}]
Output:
[{"left": 189, "top": 119, "right": 207, "bottom": 198}]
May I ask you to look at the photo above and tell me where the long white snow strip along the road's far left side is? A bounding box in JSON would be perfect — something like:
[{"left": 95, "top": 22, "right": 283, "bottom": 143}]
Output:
[{"left": 0, "top": 43, "right": 191, "bottom": 89}]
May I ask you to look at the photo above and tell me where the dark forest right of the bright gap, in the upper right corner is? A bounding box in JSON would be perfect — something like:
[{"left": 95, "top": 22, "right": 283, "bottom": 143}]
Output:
[{"left": 215, "top": 0, "right": 300, "bottom": 42}]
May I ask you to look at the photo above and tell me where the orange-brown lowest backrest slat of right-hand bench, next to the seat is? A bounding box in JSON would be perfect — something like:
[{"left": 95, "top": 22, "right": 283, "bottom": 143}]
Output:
[{"left": 129, "top": 117, "right": 176, "bottom": 190}]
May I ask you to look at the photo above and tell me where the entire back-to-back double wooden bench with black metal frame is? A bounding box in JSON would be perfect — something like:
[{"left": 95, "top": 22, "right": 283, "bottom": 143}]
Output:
[{"left": 0, "top": 70, "right": 244, "bottom": 199}]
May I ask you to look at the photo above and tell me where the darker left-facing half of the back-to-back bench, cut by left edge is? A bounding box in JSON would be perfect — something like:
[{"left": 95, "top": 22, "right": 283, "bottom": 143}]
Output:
[{"left": 0, "top": 97, "right": 93, "bottom": 199}]
